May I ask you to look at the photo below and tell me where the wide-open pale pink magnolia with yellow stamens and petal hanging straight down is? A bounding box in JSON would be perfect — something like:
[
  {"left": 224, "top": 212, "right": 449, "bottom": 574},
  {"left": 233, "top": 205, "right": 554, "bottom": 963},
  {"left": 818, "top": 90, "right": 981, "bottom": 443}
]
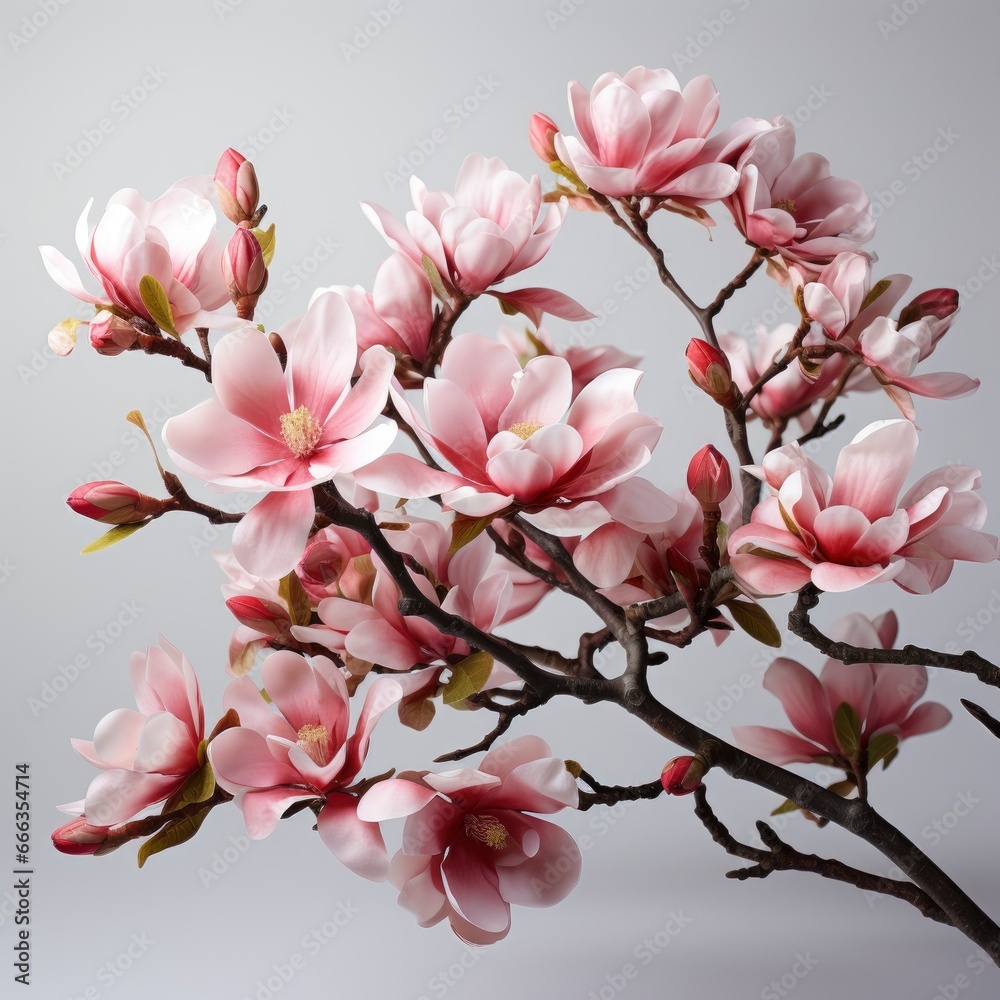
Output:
[{"left": 163, "top": 292, "right": 396, "bottom": 579}]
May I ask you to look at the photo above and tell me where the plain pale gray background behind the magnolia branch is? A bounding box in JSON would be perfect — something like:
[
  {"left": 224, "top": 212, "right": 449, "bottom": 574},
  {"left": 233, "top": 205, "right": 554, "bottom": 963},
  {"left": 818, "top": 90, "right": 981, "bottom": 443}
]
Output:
[{"left": 0, "top": 0, "right": 1000, "bottom": 1000}]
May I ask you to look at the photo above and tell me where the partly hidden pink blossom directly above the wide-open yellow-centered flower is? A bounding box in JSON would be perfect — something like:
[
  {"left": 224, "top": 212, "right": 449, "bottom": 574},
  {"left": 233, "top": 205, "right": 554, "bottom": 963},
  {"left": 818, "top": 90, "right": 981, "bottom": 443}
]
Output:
[{"left": 313, "top": 253, "right": 434, "bottom": 377}]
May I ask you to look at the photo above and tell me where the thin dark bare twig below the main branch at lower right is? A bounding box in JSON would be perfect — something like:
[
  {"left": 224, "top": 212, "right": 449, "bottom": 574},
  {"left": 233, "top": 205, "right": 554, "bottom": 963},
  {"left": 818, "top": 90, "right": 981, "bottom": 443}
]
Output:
[{"left": 694, "top": 785, "right": 954, "bottom": 926}]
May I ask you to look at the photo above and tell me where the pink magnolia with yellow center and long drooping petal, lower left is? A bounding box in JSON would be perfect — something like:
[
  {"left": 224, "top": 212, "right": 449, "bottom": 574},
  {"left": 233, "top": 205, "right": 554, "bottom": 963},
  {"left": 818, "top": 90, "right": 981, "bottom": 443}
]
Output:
[{"left": 208, "top": 652, "right": 414, "bottom": 880}]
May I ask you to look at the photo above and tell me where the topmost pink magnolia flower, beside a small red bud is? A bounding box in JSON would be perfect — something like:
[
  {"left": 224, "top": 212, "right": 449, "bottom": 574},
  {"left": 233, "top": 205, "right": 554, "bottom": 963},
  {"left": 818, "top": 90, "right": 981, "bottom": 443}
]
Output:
[{"left": 554, "top": 66, "right": 770, "bottom": 206}]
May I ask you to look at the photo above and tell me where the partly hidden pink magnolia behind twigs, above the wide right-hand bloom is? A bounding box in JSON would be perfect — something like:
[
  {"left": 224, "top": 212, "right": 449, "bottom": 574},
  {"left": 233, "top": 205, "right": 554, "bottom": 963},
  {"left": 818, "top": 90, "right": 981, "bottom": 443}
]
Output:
[{"left": 719, "top": 323, "right": 846, "bottom": 430}]
